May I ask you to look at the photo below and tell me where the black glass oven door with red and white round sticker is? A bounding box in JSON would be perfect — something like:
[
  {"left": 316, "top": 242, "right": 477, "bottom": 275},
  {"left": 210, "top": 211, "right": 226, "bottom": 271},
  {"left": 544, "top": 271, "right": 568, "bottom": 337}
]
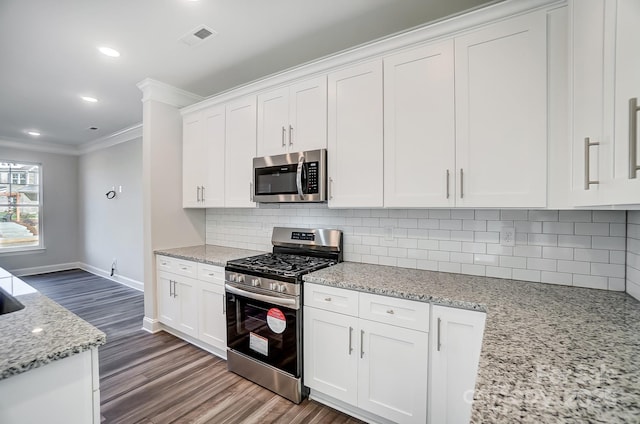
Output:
[{"left": 225, "top": 283, "right": 302, "bottom": 377}]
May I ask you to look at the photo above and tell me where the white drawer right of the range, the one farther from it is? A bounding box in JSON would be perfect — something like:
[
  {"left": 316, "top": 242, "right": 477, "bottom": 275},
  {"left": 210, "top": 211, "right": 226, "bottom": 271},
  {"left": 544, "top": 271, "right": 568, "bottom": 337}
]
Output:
[{"left": 359, "top": 293, "right": 429, "bottom": 333}]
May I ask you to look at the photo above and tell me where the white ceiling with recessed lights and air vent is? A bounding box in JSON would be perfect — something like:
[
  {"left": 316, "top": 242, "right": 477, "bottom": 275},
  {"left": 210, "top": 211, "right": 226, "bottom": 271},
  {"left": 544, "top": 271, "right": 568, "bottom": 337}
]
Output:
[{"left": 0, "top": 0, "right": 496, "bottom": 147}]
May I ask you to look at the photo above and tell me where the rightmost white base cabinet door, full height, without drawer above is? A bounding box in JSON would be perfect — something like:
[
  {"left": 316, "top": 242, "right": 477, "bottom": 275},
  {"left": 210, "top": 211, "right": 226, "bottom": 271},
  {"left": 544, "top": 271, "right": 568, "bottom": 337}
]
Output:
[{"left": 429, "top": 306, "right": 486, "bottom": 423}]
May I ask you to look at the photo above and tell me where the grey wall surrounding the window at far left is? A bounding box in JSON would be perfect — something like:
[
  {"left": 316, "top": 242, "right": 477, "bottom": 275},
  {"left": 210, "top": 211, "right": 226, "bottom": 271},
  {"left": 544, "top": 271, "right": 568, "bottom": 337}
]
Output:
[{"left": 0, "top": 147, "right": 78, "bottom": 274}]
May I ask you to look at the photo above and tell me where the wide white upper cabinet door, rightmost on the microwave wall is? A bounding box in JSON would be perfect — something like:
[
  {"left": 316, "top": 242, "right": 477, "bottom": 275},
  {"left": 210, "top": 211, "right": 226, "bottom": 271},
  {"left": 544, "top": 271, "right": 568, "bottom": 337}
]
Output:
[{"left": 455, "top": 12, "right": 547, "bottom": 207}]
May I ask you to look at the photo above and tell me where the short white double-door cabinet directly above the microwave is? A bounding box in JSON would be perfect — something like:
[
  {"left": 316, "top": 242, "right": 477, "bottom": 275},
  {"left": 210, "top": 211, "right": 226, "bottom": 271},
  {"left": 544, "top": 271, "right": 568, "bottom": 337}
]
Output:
[{"left": 257, "top": 76, "right": 327, "bottom": 156}]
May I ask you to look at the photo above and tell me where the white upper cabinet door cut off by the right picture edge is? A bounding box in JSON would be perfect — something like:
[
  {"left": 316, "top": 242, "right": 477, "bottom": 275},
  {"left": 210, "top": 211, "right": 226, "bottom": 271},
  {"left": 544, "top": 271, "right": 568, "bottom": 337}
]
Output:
[{"left": 610, "top": 0, "right": 640, "bottom": 204}]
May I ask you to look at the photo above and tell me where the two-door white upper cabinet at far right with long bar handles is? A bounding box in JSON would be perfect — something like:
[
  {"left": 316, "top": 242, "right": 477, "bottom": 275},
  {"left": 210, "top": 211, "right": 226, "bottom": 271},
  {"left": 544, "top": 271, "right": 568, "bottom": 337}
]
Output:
[{"left": 569, "top": 0, "right": 640, "bottom": 206}]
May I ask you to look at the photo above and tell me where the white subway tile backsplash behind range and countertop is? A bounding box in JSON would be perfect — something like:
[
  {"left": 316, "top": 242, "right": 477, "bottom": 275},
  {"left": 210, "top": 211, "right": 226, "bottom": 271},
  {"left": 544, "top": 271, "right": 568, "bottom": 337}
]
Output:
[{"left": 206, "top": 205, "right": 626, "bottom": 291}]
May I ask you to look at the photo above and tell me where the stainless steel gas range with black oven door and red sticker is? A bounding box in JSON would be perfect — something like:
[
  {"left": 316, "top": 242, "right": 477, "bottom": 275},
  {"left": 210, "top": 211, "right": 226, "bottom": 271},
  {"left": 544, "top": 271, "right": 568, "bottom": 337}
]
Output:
[{"left": 225, "top": 227, "right": 342, "bottom": 403}]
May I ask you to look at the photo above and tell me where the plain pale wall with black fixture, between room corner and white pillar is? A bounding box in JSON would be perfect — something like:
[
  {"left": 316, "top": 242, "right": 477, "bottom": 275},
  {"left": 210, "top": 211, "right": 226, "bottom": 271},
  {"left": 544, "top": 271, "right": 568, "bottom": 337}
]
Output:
[{"left": 78, "top": 138, "right": 144, "bottom": 289}]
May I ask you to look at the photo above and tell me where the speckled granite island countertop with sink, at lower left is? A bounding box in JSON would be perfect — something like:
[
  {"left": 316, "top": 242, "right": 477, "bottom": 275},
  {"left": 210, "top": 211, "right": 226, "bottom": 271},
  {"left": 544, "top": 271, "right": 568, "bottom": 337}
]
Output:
[{"left": 0, "top": 274, "right": 106, "bottom": 380}]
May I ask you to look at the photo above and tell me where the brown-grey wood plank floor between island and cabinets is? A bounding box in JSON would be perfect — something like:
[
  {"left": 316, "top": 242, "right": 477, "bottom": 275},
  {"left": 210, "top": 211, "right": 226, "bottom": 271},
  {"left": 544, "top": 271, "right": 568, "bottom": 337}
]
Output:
[{"left": 23, "top": 270, "right": 361, "bottom": 424}]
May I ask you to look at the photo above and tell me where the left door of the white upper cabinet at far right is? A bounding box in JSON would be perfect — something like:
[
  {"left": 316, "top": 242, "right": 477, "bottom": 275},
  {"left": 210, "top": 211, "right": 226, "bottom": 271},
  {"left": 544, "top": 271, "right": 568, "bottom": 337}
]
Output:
[{"left": 569, "top": 0, "right": 614, "bottom": 206}]
